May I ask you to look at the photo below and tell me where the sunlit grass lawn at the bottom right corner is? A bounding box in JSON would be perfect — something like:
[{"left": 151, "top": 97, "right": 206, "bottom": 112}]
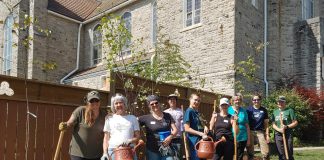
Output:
[{"left": 256, "top": 149, "right": 324, "bottom": 160}]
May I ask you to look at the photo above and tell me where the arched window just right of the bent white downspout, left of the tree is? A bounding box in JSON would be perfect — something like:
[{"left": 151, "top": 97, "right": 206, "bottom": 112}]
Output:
[{"left": 91, "top": 24, "right": 103, "bottom": 66}]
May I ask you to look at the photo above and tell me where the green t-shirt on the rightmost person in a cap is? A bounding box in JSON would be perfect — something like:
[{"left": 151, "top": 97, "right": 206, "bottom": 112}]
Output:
[{"left": 271, "top": 108, "right": 296, "bottom": 132}]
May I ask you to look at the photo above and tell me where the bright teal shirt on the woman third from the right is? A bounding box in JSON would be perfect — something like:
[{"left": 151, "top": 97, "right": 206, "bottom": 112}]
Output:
[{"left": 228, "top": 106, "right": 249, "bottom": 142}]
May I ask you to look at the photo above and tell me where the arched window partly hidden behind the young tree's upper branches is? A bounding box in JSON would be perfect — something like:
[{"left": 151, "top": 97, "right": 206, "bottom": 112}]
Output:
[{"left": 122, "top": 12, "right": 132, "bottom": 56}]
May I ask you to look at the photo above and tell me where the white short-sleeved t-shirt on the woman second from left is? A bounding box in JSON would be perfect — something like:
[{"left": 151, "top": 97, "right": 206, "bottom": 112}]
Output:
[{"left": 103, "top": 114, "right": 140, "bottom": 148}]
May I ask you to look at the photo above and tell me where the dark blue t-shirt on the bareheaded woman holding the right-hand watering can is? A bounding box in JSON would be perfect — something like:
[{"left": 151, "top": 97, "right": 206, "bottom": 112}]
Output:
[{"left": 183, "top": 107, "right": 204, "bottom": 144}]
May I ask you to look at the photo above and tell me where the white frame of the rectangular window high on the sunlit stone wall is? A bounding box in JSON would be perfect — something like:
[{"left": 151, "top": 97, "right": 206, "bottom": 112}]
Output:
[{"left": 184, "top": 0, "right": 202, "bottom": 28}]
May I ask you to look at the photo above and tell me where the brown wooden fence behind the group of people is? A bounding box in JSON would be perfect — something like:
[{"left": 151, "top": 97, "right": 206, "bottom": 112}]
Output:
[{"left": 0, "top": 75, "right": 224, "bottom": 160}]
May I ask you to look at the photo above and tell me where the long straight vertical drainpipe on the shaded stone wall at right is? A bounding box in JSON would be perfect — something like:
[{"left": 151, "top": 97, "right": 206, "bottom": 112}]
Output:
[{"left": 263, "top": 0, "right": 269, "bottom": 97}]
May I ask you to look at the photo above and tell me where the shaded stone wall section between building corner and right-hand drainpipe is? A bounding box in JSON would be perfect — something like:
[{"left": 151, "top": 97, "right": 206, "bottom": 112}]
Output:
[{"left": 234, "top": 0, "right": 265, "bottom": 93}]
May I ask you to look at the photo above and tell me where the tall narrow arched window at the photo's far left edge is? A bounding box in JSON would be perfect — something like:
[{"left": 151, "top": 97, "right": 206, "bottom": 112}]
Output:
[{"left": 2, "top": 15, "right": 14, "bottom": 75}]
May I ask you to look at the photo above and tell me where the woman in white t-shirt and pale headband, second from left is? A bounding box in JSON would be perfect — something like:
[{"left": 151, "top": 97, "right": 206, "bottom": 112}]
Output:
[{"left": 101, "top": 93, "right": 141, "bottom": 160}]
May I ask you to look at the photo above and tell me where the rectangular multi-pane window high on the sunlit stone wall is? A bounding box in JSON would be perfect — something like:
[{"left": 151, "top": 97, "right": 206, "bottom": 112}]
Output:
[{"left": 185, "top": 0, "right": 201, "bottom": 27}]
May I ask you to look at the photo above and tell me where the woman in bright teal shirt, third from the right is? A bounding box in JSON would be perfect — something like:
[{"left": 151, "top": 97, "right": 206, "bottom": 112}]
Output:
[{"left": 228, "top": 94, "right": 250, "bottom": 160}]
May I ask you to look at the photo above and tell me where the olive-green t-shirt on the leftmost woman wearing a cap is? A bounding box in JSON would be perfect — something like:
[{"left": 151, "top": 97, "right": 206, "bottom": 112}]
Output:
[{"left": 70, "top": 106, "right": 106, "bottom": 159}]
